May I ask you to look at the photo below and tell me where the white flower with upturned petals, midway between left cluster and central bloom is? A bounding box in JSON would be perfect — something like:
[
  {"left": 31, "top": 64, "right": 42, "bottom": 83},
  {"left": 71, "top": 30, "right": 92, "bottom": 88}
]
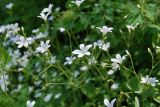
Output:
[{"left": 36, "top": 40, "right": 50, "bottom": 53}]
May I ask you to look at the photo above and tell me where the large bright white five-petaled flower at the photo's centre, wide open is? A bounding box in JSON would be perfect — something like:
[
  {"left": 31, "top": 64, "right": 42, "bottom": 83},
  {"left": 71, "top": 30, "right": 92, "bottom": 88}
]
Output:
[{"left": 72, "top": 44, "right": 92, "bottom": 57}]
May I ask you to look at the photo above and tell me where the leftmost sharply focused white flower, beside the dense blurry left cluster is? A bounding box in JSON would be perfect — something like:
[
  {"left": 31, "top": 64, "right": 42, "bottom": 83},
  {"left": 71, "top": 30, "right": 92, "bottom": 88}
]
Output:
[{"left": 16, "top": 36, "right": 32, "bottom": 48}]
